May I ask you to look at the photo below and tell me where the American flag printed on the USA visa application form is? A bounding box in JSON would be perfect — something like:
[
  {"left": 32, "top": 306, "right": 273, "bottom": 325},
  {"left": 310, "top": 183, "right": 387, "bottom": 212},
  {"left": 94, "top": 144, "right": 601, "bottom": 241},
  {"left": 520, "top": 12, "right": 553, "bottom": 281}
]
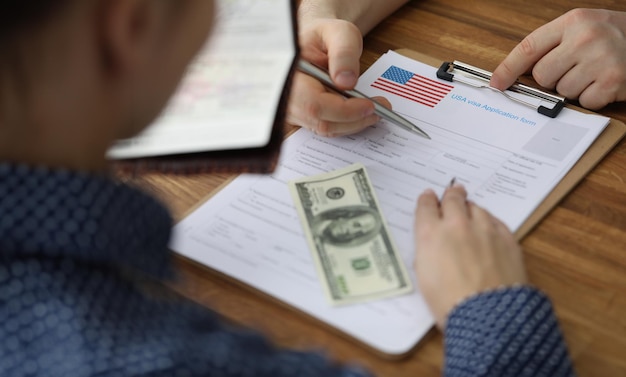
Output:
[{"left": 371, "top": 65, "right": 454, "bottom": 107}]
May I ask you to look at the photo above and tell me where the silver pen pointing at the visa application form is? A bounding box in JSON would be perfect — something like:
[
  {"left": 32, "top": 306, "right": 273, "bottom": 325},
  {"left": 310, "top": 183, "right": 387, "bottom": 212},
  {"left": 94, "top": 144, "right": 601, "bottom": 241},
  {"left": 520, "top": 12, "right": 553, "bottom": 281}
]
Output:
[{"left": 298, "top": 59, "right": 430, "bottom": 139}]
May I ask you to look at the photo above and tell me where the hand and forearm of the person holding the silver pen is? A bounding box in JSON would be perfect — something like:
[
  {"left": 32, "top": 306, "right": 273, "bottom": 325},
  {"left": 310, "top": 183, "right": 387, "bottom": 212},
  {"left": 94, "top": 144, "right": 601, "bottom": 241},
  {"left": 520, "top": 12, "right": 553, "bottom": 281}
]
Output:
[{"left": 287, "top": 0, "right": 408, "bottom": 137}]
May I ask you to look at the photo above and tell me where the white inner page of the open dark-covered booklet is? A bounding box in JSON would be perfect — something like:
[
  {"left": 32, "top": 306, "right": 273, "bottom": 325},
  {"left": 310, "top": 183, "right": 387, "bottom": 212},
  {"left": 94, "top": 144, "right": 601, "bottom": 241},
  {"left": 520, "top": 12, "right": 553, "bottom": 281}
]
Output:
[{"left": 108, "top": 0, "right": 296, "bottom": 159}]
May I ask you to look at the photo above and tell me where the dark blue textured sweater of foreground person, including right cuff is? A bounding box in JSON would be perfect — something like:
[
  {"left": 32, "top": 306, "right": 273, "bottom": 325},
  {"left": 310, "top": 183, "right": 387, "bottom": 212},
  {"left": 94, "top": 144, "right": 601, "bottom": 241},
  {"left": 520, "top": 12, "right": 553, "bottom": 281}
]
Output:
[{"left": 0, "top": 164, "right": 573, "bottom": 377}]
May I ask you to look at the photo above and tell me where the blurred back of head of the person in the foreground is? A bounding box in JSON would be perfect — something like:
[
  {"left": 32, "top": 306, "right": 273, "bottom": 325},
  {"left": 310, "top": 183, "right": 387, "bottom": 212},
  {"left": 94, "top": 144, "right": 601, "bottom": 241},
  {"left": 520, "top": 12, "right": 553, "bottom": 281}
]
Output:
[{"left": 0, "top": 0, "right": 213, "bottom": 170}]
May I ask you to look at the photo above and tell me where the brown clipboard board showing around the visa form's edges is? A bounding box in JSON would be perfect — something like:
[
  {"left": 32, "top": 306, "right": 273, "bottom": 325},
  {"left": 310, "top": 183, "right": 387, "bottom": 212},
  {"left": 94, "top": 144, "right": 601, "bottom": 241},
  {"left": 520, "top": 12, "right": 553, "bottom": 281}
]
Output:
[{"left": 396, "top": 49, "right": 626, "bottom": 241}]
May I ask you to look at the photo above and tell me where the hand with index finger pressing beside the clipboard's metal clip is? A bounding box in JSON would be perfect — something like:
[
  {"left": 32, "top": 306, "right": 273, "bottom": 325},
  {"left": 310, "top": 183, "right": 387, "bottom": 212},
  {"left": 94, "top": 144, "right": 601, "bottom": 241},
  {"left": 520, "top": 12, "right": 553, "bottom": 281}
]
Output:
[{"left": 490, "top": 9, "right": 626, "bottom": 109}]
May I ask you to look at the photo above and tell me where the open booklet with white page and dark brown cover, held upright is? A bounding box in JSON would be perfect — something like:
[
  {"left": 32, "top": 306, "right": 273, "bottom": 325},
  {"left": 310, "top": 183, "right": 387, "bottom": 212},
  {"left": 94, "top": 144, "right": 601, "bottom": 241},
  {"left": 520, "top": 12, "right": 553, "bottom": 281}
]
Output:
[{"left": 108, "top": 0, "right": 299, "bottom": 174}]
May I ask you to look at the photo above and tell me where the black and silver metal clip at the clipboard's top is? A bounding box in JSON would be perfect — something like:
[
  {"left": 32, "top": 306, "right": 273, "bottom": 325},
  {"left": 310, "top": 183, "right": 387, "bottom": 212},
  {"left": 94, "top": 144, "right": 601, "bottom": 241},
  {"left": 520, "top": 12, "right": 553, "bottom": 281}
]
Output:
[{"left": 437, "top": 60, "right": 565, "bottom": 118}]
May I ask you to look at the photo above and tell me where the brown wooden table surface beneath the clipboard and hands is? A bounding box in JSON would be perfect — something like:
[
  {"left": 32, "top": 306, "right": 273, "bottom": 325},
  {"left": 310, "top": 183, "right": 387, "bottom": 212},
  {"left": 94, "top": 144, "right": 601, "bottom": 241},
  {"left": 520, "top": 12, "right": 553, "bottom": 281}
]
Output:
[{"left": 120, "top": 0, "right": 626, "bottom": 376}]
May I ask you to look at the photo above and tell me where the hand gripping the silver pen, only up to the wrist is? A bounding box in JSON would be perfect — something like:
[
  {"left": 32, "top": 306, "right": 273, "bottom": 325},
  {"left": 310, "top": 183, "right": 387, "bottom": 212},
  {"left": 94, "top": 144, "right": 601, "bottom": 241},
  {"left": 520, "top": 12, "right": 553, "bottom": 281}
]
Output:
[{"left": 287, "top": 19, "right": 391, "bottom": 137}]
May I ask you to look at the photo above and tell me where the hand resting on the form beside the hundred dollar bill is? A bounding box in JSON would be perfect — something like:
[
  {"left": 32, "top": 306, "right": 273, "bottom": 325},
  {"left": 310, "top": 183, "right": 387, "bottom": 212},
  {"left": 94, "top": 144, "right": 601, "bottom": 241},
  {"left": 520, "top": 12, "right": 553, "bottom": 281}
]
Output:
[{"left": 415, "top": 185, "right": 527, "bottom": 329}]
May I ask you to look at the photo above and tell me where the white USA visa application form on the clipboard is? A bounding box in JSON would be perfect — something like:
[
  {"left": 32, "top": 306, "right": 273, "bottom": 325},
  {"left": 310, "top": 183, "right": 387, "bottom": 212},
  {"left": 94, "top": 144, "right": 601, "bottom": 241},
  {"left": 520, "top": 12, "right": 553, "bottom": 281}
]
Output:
[{"left": 171, "top": 52, "right": 609, "bottom": 354}]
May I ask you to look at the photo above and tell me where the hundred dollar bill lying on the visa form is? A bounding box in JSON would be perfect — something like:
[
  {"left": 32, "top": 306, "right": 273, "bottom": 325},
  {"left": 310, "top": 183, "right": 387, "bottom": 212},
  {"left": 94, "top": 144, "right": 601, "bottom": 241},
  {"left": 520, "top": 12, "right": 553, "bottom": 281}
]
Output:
[{"left": 289, "top": 164, "right": 413, "bottom": 305}]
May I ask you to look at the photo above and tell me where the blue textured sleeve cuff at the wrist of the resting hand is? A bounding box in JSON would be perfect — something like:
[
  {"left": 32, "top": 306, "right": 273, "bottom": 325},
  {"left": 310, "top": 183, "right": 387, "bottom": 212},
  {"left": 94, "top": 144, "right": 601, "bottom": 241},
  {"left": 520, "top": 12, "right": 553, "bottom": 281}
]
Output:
[{"left": 444, "top": 286, "right": 575, "bottom": 377}]
